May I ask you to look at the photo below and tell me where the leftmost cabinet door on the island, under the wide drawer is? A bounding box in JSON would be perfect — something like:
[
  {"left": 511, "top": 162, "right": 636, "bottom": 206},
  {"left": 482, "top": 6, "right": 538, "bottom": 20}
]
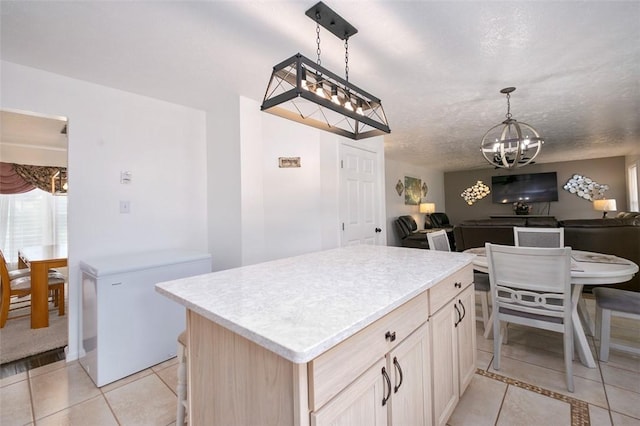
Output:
[{"left": 311, "top": 358, "right": 393, "bottom": 426}]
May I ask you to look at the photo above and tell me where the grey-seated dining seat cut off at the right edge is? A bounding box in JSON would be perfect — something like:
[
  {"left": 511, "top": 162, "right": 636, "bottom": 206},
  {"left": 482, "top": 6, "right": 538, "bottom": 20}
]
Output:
[{"left": 593, "top": 287, "right": 640, "bottom": 361}]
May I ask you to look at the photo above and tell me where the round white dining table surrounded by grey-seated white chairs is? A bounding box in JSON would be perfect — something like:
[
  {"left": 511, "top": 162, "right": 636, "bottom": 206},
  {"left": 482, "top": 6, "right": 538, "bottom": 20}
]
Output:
[{"left": 464, "top": 247, "right": 638, "bottom": 368}]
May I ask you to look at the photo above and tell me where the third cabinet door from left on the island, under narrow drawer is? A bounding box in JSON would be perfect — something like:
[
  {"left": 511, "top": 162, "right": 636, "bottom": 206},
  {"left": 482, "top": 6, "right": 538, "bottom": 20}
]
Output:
[{"left": 429, "top": 298, "right": 460, "bottom": 425}]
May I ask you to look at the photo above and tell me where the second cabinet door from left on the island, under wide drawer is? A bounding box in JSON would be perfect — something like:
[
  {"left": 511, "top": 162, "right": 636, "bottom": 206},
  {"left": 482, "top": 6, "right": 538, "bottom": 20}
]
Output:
[{"left": 387, "top": 324, "right": 431, "bottom": 426}]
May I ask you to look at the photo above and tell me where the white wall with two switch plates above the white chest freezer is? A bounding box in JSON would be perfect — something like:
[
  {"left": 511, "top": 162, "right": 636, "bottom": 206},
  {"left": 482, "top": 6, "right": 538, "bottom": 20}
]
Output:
[{"left": 0, "top": 62, "right": 207, "bottom": 359}]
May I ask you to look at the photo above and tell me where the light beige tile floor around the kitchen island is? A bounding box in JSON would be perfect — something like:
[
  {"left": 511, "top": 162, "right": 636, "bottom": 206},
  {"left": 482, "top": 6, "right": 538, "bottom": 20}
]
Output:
[{"left": 0, "top": 294, "right": 640, "bottom": 426}]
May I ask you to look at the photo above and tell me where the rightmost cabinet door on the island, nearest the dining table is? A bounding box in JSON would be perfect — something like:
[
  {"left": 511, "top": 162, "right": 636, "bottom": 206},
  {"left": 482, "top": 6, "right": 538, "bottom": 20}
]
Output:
[{"left": 455, "top": 286, "right": 476, "bottom": 396}]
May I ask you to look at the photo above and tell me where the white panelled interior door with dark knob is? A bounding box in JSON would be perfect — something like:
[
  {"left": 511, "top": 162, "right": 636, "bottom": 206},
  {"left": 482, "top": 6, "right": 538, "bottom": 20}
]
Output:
[{"left": 340, "top": 144, "right": 384, "bottom": 246}]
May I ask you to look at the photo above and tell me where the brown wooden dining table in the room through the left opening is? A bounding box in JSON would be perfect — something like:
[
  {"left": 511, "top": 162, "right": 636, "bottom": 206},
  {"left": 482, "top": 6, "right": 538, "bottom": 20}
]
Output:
[{"left": 18, "top": 244, "right": 67, "bottom": 328}]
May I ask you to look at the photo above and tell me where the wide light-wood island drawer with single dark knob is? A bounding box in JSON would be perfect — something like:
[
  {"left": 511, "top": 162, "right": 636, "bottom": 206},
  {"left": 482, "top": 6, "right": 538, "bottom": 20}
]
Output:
[{"left": 309, "top": 292, "right": 429, "bottom": 411}]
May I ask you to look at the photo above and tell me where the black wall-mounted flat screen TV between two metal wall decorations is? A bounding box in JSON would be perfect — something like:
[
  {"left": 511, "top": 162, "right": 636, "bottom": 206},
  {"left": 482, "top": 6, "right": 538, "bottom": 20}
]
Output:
[{"left": 491, "top": 172, "right": 558, "bottom": 204}]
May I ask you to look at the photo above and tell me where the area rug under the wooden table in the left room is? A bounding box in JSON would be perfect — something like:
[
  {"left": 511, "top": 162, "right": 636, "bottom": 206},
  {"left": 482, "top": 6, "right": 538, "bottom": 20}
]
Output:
[{"left": 0, "top": 302, "right": 68, "bottom": 364}]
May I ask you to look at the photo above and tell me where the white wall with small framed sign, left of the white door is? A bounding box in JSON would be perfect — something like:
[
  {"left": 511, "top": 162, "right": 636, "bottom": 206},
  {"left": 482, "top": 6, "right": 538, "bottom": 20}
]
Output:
[{"left": 240, "top": 97, "right": 376, "bottom": 265}]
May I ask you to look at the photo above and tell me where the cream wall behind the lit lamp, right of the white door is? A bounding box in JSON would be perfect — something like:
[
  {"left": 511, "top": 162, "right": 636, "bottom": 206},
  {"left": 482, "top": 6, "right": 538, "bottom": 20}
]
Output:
[{"left": 384, "top": 159, "right": 447, "bottom": 246}]
